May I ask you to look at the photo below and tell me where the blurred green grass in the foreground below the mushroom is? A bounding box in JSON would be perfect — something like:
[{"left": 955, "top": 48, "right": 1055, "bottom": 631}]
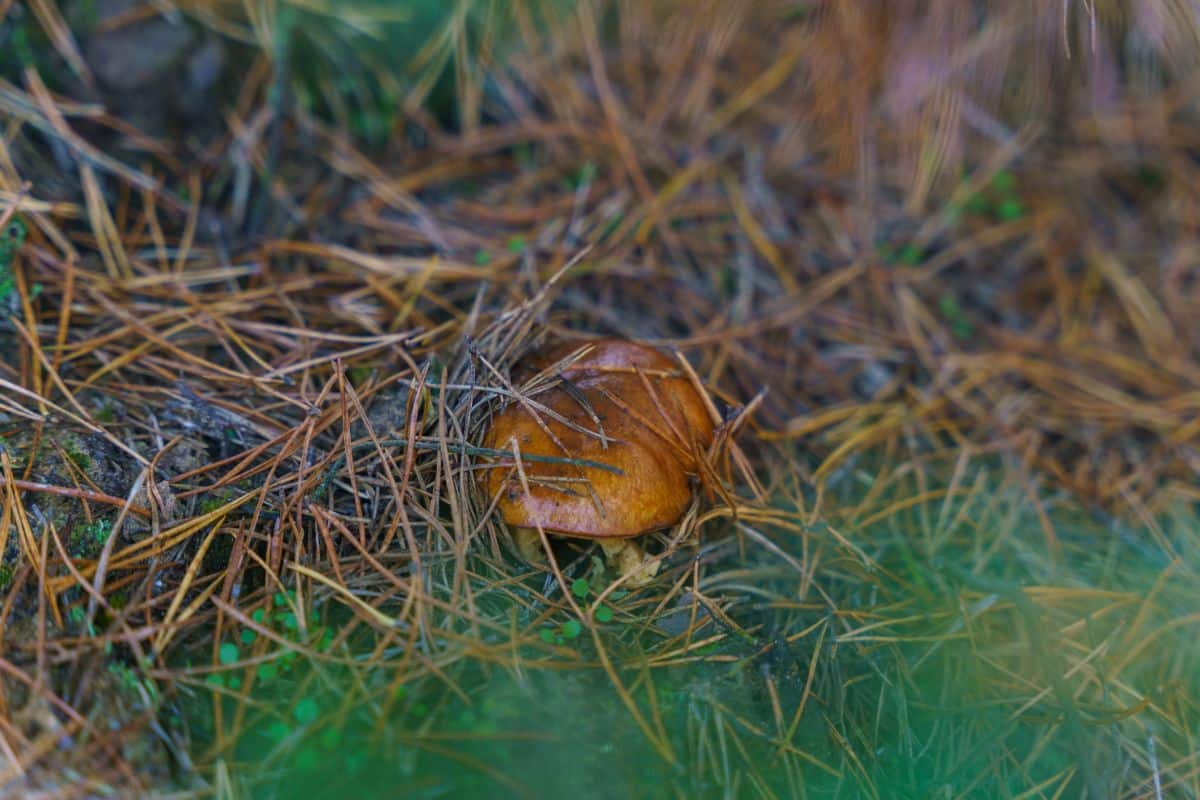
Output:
[{"left": 177, "top": 453, "right": 1200, "bottom": 799}]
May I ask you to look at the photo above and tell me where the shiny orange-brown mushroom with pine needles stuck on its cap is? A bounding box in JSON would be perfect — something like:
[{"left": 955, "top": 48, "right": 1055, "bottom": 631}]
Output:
[{"left": 482, "top": 339, "right": 714, "bottom": 585}]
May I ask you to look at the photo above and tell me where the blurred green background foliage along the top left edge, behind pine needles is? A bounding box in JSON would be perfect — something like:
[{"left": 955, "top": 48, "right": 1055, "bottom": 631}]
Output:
[{"left": 0, "top": 0, "right": 572, "bottom": 146}]
